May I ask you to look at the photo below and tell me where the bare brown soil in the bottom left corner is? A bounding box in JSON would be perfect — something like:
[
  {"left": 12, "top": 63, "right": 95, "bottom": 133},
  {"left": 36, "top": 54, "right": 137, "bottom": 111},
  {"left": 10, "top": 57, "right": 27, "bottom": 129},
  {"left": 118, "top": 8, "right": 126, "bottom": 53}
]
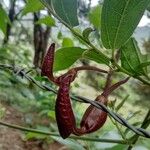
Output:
[{"left": 0, "top": 104, "right": 67, "bottom": 150}]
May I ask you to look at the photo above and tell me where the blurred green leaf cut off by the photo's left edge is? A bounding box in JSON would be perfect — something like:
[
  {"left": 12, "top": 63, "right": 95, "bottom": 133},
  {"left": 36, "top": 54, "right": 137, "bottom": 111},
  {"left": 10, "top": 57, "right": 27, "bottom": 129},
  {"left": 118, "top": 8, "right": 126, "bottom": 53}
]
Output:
[{"left": 0, "top": 5, "right": 11, "bottom": 34}]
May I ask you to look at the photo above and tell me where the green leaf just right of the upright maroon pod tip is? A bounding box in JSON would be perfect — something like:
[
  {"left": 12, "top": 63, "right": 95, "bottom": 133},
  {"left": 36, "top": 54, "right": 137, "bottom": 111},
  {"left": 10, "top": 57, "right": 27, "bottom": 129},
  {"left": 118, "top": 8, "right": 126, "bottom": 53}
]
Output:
[{"left": 54, "top": 47, "right": 85, "bottom": 71}]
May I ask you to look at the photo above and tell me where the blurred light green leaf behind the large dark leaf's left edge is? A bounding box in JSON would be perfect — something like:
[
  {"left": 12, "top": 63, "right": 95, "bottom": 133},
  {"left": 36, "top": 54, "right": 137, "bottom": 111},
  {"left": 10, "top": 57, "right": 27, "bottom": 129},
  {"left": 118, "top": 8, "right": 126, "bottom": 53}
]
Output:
[{"left": 88, "top": 5, "right": 102, "bottom": 30}]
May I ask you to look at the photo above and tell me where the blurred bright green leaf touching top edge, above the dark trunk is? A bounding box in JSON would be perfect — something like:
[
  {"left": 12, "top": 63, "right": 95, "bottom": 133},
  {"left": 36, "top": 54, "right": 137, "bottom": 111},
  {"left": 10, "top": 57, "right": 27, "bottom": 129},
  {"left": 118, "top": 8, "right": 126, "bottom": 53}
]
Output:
[{"left": 22, "top": 0, "right": 44, "bottom": 16}]
